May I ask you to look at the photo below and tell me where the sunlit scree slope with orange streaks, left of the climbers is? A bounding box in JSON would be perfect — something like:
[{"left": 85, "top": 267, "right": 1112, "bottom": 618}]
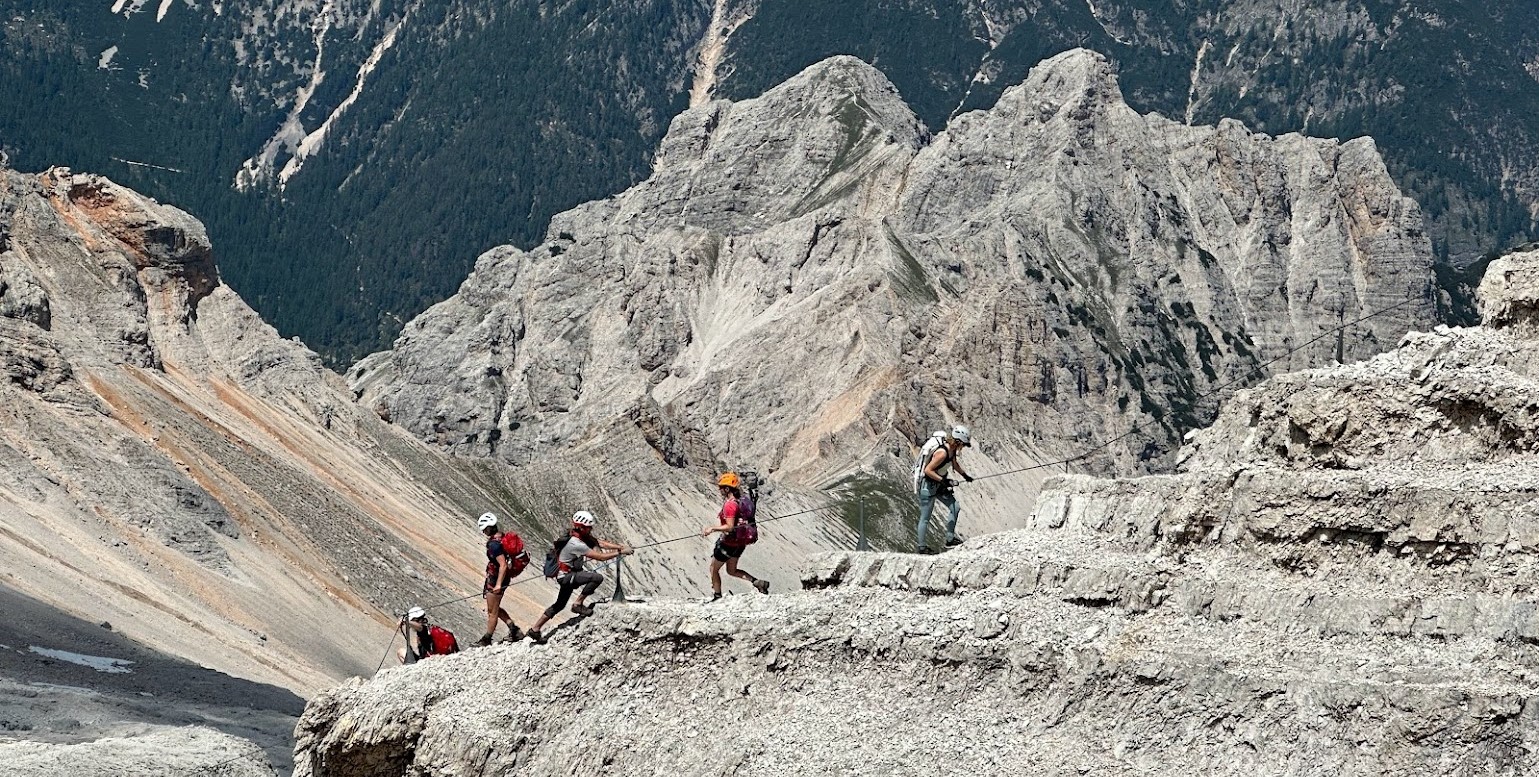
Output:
[{"left": 0, "top": 168, "right": 560, "bottom": 691}]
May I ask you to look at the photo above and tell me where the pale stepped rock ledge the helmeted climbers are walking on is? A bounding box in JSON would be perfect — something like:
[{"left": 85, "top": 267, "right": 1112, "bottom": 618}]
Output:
[{"left": 295, "top": 252, "right": 1539, "bottom": 777}]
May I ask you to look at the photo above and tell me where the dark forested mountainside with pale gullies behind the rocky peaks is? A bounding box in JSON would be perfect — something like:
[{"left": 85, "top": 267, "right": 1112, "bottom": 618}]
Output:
[{"left": 0, "top": 0, "right": 1539, "bottom": 358}]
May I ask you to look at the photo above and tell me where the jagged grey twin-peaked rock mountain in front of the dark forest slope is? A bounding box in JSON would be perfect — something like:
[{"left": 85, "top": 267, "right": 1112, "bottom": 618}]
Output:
[{"left": 348, "top": 51, "right": 1433, "bottom": 497}]
